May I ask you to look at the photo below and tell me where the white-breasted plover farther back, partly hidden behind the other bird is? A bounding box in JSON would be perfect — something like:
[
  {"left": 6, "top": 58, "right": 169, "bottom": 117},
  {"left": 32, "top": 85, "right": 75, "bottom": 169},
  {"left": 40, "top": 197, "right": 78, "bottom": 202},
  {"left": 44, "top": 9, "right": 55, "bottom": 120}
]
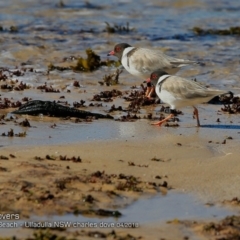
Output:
[{"left": 108, "top": 43, "right": 199, "bottom": 97}]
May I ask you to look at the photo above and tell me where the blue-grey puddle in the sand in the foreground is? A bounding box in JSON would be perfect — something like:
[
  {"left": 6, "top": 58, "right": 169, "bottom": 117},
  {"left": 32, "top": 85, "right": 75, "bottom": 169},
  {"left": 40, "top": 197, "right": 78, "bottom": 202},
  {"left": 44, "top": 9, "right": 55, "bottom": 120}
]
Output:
[{"left": 34, "top": 191, "right": 236, "bottom": 224}]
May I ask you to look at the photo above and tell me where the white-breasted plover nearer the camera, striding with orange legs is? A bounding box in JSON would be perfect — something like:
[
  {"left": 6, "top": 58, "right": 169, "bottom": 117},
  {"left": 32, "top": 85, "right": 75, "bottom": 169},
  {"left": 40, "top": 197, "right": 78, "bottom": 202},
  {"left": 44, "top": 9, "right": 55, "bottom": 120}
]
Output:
[{"left": 150, "top": 70, "right": 229, "bottom": 127}]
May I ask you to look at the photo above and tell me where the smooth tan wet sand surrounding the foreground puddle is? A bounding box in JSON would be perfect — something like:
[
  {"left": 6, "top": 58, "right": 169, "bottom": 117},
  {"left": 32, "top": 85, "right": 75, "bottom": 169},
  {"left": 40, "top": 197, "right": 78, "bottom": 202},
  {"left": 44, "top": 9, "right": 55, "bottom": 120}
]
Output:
[{"left": 0, "top": 122, "right": 240, "bottom": 239}]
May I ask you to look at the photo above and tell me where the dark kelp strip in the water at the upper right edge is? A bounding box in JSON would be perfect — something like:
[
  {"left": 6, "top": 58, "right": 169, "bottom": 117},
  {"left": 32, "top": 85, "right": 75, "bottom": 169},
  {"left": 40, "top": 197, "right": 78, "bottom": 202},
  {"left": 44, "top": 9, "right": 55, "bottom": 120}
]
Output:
[{"left": 192, "top": 27, "right": 240, "bottom": 36}]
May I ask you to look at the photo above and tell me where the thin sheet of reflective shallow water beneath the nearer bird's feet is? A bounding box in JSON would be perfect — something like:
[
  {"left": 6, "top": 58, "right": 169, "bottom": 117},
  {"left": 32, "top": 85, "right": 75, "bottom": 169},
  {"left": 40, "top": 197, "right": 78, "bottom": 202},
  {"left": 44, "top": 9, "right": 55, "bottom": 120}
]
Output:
[{"left": 0, "top": 105, "right": 240, "bottom": 149}]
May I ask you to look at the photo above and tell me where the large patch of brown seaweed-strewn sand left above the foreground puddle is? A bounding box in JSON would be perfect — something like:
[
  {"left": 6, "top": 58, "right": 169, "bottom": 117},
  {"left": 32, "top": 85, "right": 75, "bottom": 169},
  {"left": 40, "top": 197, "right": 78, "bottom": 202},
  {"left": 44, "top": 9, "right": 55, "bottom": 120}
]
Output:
[{"left": 0, "top": 158, "right": 169, "bottom": 217}]
